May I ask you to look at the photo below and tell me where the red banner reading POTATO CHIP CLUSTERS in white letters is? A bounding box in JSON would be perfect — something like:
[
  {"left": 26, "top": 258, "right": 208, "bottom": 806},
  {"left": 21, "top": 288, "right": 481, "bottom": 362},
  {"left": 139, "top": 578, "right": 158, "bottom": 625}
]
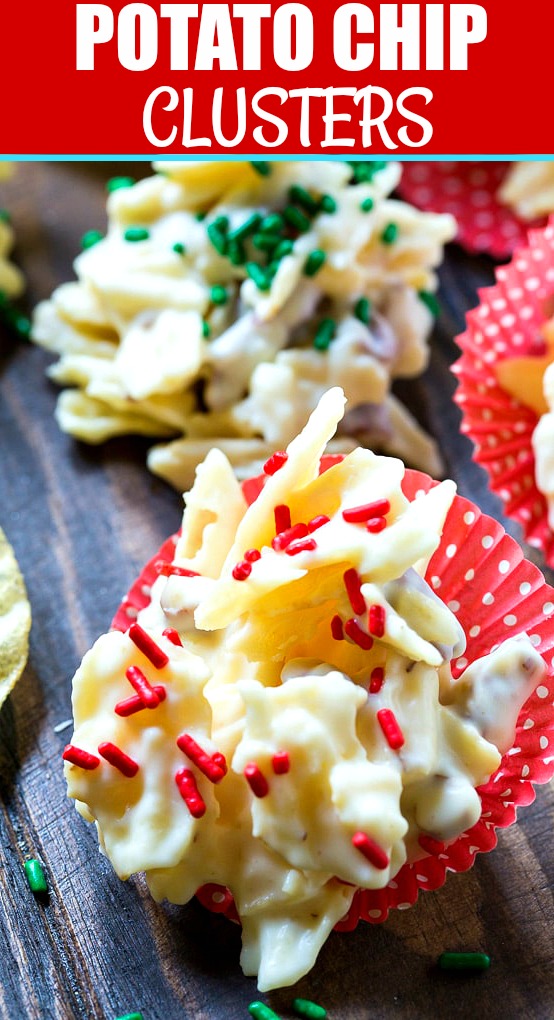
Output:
[{"left": 0, "top": 0, "right": 554, "bottom": 157}]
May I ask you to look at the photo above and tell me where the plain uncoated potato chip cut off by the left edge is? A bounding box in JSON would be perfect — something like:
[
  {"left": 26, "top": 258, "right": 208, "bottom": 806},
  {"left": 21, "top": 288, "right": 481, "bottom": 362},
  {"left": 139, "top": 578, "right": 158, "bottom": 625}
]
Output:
[{"left": 0, "top": 528, "right": 31, "bottom": 705}]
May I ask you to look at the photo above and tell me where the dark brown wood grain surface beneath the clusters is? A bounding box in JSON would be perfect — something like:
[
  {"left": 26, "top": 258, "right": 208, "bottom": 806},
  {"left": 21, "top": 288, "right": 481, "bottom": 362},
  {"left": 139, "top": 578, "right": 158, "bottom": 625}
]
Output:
[{"left": 0, "top": 163, "right": 554, "bottom": 1020}]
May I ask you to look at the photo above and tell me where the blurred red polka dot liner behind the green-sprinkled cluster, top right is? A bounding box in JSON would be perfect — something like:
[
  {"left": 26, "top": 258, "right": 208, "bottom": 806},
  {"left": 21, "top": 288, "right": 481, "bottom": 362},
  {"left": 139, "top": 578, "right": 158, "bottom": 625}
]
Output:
[{"left": 398, "top": 162, "right": 545, "bottom": 260}]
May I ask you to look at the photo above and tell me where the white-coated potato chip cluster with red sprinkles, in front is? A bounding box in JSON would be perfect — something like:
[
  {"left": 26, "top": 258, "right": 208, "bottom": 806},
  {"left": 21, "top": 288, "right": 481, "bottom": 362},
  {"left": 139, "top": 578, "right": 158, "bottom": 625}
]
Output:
[{"left": 66, "top": 390, "right": 545, "bottom": 990}]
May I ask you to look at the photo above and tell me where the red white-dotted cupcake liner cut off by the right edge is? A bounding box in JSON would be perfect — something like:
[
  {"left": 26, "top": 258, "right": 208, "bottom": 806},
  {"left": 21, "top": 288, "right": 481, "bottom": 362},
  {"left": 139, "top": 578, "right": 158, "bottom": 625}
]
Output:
[{"left": 453, "top": 216, "right": 554, "bottom": 567}]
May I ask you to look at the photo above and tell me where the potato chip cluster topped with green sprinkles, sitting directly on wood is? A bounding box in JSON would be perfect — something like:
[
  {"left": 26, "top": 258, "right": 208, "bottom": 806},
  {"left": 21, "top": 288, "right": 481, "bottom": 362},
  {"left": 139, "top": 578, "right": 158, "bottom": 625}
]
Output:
[{"left": 34, "top": 161, "right": 454, "bottom": 490}]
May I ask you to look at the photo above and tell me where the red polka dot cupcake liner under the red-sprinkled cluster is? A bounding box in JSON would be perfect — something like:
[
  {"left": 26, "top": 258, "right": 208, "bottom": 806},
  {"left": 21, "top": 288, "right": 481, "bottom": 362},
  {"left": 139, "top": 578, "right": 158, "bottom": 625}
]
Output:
[{"left": 112, "top": 458, "right": 554, "bottom": 931}]
